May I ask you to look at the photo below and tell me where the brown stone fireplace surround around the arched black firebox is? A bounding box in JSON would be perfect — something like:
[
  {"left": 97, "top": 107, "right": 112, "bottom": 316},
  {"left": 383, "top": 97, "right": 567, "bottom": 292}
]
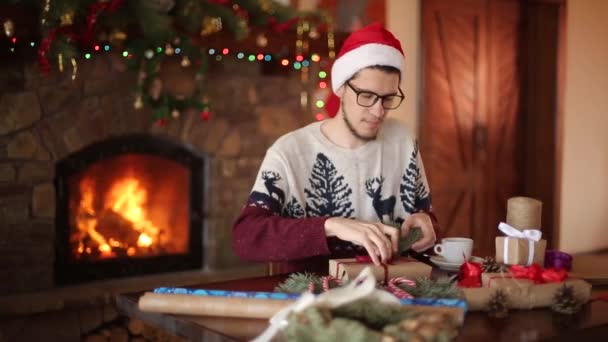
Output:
[{"left": 0, "top": 56, "right": 313, "bottom": 299}]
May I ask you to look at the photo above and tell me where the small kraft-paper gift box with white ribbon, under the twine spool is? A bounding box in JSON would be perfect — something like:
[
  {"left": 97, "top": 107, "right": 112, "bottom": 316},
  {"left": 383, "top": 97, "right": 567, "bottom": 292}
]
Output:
[{"left": 496, "top": 236, "right": 547, "bottom": 265}]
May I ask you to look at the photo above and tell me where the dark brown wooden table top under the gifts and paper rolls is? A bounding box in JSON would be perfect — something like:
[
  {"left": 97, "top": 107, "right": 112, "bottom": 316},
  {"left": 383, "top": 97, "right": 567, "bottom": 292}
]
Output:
[{"left": 116, "top": 276, "right": 608, "bottom": 342}]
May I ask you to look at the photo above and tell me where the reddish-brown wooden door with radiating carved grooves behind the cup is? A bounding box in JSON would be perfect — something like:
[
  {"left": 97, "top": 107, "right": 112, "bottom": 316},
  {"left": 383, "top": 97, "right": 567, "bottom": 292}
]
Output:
[{"left": 420, "top": 0, "right": 521, "bottom": 255}]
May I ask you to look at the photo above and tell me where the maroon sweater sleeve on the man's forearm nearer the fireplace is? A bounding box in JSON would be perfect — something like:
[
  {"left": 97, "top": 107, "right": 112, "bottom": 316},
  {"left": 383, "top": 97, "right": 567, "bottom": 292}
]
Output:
[{"left": 232, "top": 205, "right": 330, "bottom": 262}]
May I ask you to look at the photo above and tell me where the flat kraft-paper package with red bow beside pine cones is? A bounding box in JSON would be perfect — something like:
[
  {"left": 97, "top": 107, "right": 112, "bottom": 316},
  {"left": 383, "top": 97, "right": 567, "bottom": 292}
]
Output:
[{"left": 462, "top": 279, "right": 591, "bottom": 311}]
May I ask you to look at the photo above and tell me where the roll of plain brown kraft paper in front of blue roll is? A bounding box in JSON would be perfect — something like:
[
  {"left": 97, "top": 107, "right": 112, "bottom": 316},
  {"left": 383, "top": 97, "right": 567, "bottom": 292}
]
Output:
[{"left": 139, "top": 292, "right": 294, "bottom": 319}]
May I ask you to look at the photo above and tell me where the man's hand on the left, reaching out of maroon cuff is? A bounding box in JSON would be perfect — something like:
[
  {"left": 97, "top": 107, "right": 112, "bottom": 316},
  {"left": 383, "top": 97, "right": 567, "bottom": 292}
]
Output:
[{"left": 325, "top": 217, "right": 400, "bottom": 265}]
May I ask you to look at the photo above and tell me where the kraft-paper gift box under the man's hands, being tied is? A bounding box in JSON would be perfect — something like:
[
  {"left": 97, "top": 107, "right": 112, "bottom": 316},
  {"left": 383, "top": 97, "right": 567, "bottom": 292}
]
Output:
[{"left": 329, "top": 258, "right": 432, "bottom": 282}]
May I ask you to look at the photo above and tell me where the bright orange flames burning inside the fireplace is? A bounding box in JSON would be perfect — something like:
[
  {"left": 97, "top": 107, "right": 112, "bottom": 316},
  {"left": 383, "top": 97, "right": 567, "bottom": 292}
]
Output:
[{"left": 76, "top": 177, "right": 161, "bottom": 258}]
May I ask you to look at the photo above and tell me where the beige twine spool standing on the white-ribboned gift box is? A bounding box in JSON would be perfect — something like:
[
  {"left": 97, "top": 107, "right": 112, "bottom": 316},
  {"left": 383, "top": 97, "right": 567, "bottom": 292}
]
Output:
[{"left": 507, "top": 197, "right": 543, "bottom": 230}]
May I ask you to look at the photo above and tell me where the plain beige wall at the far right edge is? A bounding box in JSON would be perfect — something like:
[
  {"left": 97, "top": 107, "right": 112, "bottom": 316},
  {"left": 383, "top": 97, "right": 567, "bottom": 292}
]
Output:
[{"left": 558, "top": 0, "right": 608, "bottom": 253}]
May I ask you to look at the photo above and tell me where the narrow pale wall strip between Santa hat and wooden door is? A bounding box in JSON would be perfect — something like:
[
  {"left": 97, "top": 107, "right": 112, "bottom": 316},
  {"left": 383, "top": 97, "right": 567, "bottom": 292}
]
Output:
[{"left": 386, "top": 0, "right": 421, "bottom": 134}]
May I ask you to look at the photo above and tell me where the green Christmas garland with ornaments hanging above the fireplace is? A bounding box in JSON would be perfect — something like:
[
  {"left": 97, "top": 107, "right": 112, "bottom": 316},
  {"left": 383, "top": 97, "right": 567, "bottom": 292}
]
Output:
[{"left": 24, "top": 0, "right": 326, "bottom": 125}]
